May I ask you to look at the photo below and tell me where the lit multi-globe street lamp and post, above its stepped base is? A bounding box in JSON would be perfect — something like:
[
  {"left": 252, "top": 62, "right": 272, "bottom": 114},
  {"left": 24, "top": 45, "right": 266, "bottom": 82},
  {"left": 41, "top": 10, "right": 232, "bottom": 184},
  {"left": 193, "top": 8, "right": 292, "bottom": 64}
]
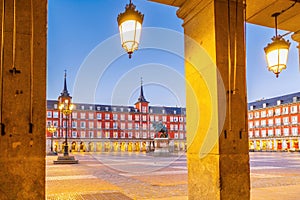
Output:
[{"left": 59, "top": 99, "right": 73, "bottom": 156}]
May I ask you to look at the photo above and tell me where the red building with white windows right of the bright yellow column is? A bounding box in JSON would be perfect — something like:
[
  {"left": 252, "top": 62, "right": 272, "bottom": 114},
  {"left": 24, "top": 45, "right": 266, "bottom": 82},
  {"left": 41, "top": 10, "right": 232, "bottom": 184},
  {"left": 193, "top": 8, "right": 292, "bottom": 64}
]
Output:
[{"left": 248, "top": 92, "right": 300, "bottom": 151}]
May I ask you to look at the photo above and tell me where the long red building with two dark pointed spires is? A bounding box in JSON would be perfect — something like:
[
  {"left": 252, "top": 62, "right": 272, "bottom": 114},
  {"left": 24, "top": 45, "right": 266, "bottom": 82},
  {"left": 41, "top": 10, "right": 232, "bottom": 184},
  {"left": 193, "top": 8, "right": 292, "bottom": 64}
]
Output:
[{"left": 46, "top": 75, "right": 186, "bottom": 152}]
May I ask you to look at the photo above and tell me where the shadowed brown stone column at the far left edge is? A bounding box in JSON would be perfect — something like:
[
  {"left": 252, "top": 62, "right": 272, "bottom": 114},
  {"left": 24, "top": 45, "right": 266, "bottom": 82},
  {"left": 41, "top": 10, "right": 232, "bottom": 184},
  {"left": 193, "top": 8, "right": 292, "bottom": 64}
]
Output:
[{"left": 0, "top": 0, "right": 47, "bottom": 199}]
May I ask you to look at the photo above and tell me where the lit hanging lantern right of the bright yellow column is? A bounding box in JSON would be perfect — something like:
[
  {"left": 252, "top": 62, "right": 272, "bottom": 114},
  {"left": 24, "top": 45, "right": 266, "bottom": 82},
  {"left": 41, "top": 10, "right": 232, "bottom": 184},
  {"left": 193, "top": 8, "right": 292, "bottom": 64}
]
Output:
[{"left": 264, "top": 36, "right": 291, "bottom": 78}]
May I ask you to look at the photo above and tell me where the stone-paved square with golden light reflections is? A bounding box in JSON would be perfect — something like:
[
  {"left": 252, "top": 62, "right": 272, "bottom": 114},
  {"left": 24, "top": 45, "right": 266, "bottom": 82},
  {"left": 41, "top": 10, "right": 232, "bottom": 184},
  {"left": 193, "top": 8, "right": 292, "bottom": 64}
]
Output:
[{"left": 46, "top": 152, "right": 300, "bottom": 200}]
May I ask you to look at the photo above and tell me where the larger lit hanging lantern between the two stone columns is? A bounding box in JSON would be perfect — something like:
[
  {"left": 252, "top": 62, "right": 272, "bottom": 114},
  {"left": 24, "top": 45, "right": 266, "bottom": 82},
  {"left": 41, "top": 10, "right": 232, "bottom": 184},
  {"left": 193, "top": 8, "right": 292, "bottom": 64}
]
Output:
[{"left": 117, "top": 0, "right": 144, "bottom": 58}]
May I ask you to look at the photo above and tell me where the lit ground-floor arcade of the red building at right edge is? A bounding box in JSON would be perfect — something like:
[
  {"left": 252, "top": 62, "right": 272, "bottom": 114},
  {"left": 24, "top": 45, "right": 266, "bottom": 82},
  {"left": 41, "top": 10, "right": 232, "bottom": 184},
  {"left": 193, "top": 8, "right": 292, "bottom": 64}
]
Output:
[{"left": 249, "top": 137, "right": 300, "bottom": 151}]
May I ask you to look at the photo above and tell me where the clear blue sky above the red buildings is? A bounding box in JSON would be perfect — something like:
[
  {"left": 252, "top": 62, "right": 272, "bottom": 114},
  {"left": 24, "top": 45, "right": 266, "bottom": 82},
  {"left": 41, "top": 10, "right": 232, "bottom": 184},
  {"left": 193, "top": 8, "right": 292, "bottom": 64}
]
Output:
[{"left": 47, "top": 0, "right": 300, "bottom": 106}]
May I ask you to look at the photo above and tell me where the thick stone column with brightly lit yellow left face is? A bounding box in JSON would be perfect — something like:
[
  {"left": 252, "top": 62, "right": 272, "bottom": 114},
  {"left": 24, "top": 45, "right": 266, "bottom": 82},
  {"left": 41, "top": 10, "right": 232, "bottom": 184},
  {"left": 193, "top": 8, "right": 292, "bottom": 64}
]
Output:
[{"left": 177, "top": 0, "right": 250, "bottom": 200}]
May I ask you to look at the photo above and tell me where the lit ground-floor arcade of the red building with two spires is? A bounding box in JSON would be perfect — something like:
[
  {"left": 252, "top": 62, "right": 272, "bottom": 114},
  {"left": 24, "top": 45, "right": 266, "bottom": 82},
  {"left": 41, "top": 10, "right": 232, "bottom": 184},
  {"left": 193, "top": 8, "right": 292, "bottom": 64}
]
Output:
[{"left": 46, "top": 138, "right": 186, "bottom": 153}]
